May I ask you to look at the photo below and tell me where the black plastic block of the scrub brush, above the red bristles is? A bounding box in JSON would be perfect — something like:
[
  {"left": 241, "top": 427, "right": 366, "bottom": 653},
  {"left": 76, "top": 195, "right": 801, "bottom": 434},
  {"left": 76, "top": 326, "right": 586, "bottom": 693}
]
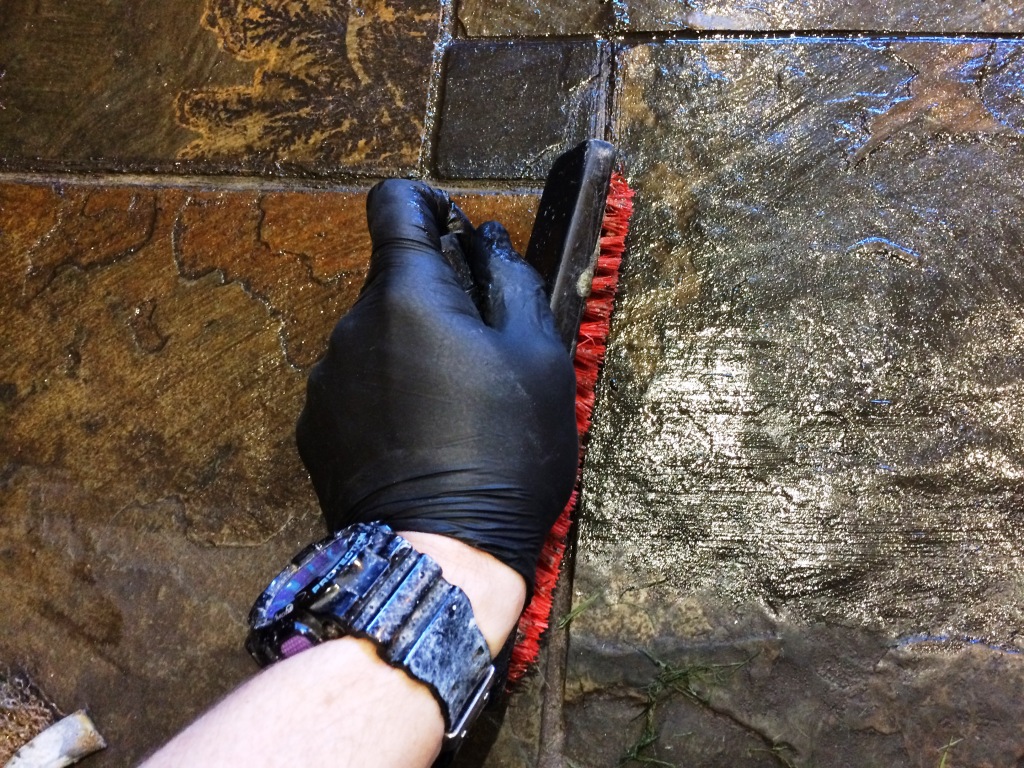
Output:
[{"left": 526, "top": 139, "right": 615, "bottom": 354}]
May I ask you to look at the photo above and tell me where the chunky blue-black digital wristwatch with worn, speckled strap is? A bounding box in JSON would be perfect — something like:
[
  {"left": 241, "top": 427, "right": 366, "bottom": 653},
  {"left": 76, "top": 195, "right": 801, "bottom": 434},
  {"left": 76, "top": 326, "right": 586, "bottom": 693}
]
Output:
[{"left": 246, "top": 523, "right": 496, "bottom": 755}]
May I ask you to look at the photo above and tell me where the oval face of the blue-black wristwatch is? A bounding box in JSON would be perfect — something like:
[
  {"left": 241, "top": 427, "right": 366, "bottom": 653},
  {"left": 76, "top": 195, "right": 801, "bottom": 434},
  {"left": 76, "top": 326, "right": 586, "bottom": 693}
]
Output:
[{"left": 250, "top": 537, "right": 353, "bottom": 629}]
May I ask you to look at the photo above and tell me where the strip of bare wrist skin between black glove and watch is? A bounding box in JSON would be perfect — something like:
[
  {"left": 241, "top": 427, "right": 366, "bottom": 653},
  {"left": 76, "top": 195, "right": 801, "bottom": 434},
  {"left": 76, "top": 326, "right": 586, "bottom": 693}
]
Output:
[{"left": 395, "top": 530, "right": 526, "bottom": 657}]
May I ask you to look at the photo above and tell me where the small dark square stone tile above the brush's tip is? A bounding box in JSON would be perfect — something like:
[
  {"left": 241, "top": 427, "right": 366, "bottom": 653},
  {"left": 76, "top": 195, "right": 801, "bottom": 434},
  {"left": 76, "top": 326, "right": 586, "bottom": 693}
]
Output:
[{"left": 437, "top": 41, "right": 607, "bottom": 179}]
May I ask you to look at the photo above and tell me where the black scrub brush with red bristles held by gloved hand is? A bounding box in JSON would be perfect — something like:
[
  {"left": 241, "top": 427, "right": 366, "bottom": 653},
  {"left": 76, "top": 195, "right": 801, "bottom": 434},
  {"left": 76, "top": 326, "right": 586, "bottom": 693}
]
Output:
[{"left": 509, "top": 139, "right": 633, "bottom": 683}]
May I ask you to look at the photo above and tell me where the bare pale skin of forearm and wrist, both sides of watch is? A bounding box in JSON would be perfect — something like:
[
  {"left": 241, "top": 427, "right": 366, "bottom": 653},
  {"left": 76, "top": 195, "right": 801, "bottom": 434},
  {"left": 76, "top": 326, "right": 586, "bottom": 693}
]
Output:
[{"left": 143, "top": 531, "right": 526, "bottom": 768}]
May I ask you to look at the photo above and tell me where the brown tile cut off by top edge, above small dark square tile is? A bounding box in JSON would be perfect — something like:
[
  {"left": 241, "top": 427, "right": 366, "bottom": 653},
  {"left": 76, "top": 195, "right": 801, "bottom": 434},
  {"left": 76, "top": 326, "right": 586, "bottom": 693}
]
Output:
[{"left": 458, "top": 0, "right": 614, "bottom": 37}]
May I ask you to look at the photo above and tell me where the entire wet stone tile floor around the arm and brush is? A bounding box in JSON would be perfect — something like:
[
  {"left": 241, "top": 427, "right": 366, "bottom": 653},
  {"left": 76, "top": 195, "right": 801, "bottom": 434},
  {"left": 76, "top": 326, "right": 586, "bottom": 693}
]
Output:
[{"left": 6, "top": 0, "right": 1024, "bottom": 768}]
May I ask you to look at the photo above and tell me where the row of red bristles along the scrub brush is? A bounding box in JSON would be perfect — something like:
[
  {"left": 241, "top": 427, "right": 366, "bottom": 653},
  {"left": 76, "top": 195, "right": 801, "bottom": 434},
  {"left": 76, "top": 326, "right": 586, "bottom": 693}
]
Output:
[{"left": 509, "top": 172, "right": 633, "bottom": 684}]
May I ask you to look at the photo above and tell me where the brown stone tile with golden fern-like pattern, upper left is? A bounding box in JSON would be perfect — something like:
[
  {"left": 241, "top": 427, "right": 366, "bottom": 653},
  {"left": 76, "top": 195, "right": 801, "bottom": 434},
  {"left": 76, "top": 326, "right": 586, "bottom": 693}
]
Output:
[{"left": 0, "top": 0, "right": 439, "bottom": 174}]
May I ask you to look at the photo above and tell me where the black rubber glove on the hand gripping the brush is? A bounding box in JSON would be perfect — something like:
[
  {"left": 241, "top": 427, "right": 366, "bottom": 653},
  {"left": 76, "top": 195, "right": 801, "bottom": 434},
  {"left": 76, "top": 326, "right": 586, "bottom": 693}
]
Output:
[{"left": 297, "top": 180, "right": 578, "bottom": 592}]
